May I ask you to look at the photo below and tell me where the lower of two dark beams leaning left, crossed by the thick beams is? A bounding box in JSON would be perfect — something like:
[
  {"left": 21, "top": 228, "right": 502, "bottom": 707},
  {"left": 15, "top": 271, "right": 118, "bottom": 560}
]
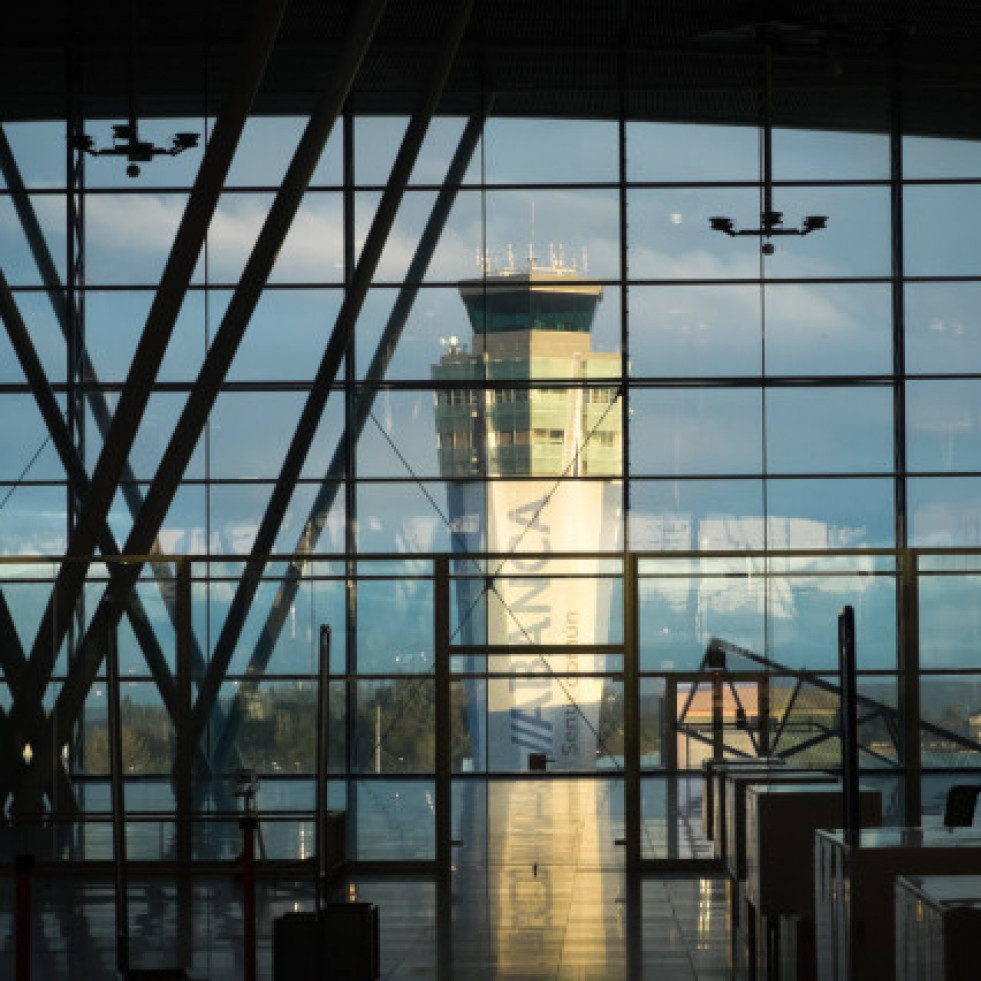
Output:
[{"left": 0, "top": 269, "right": 207, "bottom": 801}]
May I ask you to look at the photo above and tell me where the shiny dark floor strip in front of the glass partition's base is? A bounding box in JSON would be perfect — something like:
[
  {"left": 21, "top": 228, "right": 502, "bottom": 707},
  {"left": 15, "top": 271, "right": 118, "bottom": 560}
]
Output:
[{"left": 0, "top": 867, "right": 726, "bottom": 981}]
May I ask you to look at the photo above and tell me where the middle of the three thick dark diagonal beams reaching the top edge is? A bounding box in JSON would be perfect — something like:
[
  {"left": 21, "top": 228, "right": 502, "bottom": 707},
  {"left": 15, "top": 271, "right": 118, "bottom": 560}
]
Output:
[{"left": 11, "top": 0, "right": 387, "bottom": 792}]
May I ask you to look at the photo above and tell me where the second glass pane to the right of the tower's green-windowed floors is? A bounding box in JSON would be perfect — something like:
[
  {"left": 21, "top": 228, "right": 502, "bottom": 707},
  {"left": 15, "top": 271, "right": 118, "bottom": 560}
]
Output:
[{"left": 766, "top": 388, "right": 893, "bottom": 473}]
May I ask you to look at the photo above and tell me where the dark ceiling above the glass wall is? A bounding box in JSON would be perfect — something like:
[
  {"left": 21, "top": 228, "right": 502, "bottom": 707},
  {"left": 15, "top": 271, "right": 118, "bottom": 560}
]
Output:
[{"left": 0, "top": 0, "right": 981, "bottom": 136}]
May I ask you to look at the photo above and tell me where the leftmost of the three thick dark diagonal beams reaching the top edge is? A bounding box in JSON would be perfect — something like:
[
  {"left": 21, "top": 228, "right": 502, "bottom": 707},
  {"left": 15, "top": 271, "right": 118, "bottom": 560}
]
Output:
[{"left": 0, "top": 0, "right": 287, "bottom": 802}]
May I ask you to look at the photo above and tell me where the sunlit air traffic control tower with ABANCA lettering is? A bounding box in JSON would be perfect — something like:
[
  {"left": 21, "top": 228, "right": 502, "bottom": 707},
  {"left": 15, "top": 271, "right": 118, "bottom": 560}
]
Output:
[{"left": 432, "top": 256, "right": 623, "bottom": 772}]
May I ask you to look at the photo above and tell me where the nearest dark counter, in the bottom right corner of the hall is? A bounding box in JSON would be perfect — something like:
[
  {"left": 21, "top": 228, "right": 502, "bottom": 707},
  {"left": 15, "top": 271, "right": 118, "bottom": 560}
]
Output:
[{"left": 896, "top": 875, "right": 981, "bottom": 981}]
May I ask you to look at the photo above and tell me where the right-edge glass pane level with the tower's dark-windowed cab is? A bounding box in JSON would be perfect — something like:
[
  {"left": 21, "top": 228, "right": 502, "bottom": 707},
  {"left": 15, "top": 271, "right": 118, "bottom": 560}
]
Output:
[{"left": 905, "top": 283, "right": 981, "bottom": 374}]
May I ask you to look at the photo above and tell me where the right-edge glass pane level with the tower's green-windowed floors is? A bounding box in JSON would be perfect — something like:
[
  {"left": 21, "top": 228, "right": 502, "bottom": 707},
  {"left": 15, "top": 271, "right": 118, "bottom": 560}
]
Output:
[{"left": 906, "top": 379, "right": 981, "bottom": 473}]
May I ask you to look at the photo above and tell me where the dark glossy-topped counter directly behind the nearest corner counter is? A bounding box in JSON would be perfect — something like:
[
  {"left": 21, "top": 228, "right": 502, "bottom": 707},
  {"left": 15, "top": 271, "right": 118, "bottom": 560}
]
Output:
[{"left": 814, "top": 827, "right": 981, "bottom": 981}]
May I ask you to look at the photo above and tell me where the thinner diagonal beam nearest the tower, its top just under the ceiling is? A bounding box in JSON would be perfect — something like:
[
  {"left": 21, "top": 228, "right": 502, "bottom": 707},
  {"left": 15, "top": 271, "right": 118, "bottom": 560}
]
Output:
[{"left": 212, "top": 110, "right": 486, "bottom": 771}]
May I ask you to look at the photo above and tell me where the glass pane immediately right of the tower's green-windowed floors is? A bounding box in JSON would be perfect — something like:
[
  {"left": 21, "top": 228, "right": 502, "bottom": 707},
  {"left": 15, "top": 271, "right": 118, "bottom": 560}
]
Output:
[{"left": 630, "top": 389, "right": 762, "bottom": 476}]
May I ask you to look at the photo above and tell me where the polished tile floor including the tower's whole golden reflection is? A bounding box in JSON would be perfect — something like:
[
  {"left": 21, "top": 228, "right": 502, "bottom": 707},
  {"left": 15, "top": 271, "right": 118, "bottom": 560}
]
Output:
[{"left": 0, "top": 780, "right": 728, "bottom": 981}]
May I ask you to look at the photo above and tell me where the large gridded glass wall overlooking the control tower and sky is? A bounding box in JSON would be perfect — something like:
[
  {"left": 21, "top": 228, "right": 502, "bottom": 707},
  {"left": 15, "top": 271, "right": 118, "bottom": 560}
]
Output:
[{"left": 0, "top": 80, "right": 981, "bottom": 861}]
